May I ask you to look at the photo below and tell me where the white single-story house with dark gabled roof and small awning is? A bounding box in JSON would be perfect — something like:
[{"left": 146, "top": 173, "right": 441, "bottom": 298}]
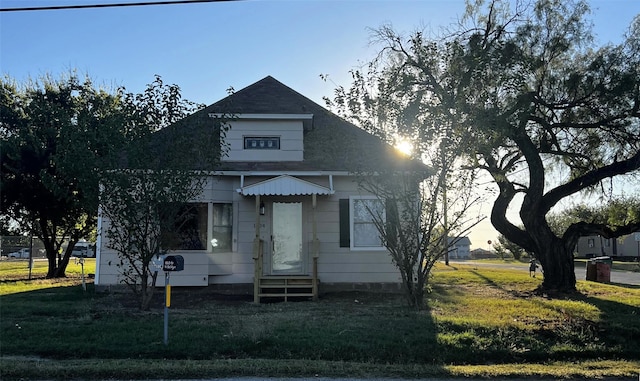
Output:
[{"left": 95, "top": 76, "right": 430, "bottom": 301}]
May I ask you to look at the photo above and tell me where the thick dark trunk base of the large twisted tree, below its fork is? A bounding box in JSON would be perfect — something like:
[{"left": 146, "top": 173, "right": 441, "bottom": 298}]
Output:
[{"left": 535, "top": 239, "right": 576, "bottom": 294}]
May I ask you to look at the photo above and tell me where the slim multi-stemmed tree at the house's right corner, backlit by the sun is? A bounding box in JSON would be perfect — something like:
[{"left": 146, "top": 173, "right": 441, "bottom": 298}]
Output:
[{"left": 325, "top": 71, "right": 482, "bottom": 309}]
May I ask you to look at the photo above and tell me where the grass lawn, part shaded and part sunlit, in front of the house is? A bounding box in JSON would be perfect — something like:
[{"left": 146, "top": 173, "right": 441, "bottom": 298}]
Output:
[{"left": 0, "top": 260, "right": 640, "bottom": 380}]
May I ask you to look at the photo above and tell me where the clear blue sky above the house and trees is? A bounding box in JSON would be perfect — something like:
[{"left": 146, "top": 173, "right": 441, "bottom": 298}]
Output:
[{"left": 0, "top": 0, "right": 640, "bottom": 249}]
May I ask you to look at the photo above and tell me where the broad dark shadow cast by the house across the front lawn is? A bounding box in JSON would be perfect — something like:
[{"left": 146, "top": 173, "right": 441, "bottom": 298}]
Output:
[{"left": 0, "top": 285, "right": 452, "bottom": 378}]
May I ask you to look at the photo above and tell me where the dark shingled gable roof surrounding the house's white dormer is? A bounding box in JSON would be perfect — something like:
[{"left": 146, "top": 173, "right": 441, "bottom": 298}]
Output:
[{"left": 153, "top": 76, "right": 430, "bottom": 174}]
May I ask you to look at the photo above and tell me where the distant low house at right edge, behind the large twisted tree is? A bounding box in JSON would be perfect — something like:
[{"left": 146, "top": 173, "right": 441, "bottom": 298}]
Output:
[{"left": 576, "top": 232, "right": 640, "bottom": 259}]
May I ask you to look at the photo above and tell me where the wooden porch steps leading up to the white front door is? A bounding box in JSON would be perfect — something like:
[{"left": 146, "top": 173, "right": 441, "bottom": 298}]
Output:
[{"left": 258, "top": 276, "right": 316, "bottom": 302}]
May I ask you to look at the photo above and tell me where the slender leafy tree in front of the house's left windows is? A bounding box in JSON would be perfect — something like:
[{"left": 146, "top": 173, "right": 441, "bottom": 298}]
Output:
[{"left": 100, "top": 77, "right": 226, "bottom": 310}]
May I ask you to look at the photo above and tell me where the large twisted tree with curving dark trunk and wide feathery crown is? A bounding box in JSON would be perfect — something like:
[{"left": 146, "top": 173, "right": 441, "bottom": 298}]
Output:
[{"left": 332, "top": 0, "right": 640, "bottom": 293}]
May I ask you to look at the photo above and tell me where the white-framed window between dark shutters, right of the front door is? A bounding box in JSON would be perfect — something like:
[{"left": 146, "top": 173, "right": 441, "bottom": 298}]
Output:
[{"left": 350, "top": 197, "right": 385, "bottom": 250}]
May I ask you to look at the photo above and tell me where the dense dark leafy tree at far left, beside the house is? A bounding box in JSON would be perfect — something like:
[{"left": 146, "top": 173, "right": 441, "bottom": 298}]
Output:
[{"left": 0, "top": 75, "right": 121, "bottom": 278}]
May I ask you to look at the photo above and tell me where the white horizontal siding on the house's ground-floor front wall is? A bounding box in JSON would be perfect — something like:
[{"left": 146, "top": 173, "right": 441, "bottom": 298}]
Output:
[{"left": 99, "top": 176, "right": 400, "bottom": 286}]
